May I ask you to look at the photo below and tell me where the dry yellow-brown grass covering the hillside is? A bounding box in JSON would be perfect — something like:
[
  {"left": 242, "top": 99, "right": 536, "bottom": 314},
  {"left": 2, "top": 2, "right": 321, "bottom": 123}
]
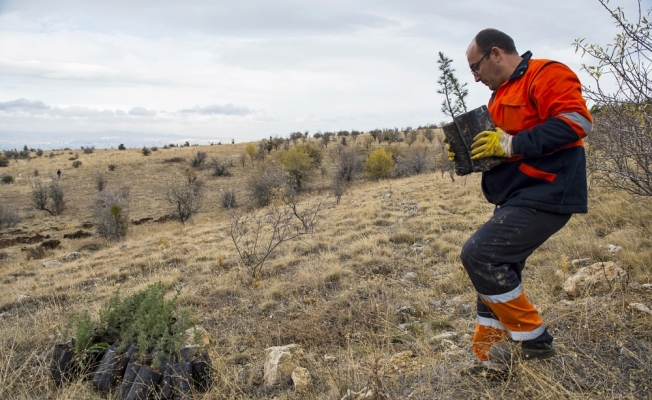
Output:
[{"left": 0, "top": 137, "right": 652, "bottom": 399}]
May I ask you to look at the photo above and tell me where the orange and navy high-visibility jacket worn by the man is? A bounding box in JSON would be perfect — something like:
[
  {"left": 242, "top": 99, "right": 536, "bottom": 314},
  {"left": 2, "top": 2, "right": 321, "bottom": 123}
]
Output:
[{"left": 482, "top": 51, "right": 592, "bottom": 214}]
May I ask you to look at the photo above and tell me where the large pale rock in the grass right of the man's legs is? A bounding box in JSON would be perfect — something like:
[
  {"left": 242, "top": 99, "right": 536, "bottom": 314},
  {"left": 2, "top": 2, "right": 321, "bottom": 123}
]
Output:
[{"left": 562, "top": 261, "right": 627, "bottom": 297}]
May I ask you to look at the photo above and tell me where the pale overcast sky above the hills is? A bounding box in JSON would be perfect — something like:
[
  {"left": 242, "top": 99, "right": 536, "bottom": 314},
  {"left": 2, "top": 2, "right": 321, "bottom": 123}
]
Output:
[{"left": 0, "top": 0, "right": 652, "bottom": 141}]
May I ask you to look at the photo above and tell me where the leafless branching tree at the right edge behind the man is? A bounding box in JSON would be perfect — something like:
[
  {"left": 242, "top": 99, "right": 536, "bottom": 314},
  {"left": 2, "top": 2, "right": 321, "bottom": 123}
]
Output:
[{"left": 574, "top": 0, "right": 652, "bottom": 196}]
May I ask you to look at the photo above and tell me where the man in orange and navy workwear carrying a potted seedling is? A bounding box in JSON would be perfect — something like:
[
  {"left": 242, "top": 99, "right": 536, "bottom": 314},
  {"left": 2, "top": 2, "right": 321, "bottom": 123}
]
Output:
[{"left": 449, "top": 29, "right": 592, "bottom": 369}]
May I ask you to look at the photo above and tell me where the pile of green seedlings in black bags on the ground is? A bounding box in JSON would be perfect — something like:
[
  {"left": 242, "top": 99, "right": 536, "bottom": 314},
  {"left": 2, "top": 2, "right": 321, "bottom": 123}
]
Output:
[{"left": 51, "top": 283, "right": 212, "bottom": 400}]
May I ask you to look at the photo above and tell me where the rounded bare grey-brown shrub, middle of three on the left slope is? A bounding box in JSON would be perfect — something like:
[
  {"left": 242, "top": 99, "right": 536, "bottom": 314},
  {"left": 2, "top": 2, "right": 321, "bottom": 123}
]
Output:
[{"left": 90, "top": 189, "right": 129, "bottom": 240}]
